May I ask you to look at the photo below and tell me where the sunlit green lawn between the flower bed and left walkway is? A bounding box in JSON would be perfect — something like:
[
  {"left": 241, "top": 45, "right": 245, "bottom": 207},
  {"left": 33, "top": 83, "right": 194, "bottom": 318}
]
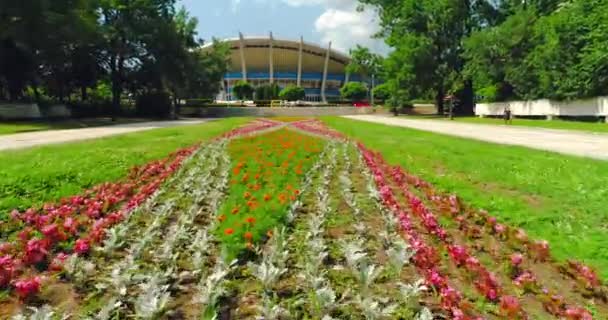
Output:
[{"left": 0, "top": 118, "right": 248, "bottom": 216}]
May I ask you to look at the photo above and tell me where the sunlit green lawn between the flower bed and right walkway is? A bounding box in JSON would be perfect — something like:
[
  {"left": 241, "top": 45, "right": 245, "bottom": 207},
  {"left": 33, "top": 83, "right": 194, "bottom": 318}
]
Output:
[{"left": 323, "top": 117, "right": 608, "bottom": 279}]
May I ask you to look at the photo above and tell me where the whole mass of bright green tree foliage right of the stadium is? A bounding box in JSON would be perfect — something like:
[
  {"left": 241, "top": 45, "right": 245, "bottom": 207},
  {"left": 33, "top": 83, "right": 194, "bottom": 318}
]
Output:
[{"left": 359, "top": 0, "right": 608, "bottom": 112}]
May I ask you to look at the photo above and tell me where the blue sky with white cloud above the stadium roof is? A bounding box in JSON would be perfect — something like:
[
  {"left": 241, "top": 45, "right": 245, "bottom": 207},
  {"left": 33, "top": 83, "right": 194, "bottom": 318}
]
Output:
[{"left": 180, "top": 0, "right": 386, "bottom": 53}]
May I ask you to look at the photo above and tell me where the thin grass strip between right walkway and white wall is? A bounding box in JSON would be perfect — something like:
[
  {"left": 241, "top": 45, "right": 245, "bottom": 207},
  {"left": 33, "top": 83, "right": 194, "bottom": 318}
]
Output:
[{"left": 414, "top": 116, "right": 608, "bottom": 133}]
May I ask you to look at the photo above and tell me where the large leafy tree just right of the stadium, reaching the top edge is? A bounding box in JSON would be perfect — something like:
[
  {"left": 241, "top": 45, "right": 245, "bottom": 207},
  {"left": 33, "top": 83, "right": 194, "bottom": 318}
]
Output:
[{"left": 360, "top": 0, "right": 500, "bottom": 113}]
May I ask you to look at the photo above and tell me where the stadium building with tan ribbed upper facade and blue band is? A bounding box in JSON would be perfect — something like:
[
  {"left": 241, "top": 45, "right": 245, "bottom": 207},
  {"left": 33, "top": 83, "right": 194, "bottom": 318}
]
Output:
[{"left": 203, "top": 33, "right": 361, "bottom": 102}]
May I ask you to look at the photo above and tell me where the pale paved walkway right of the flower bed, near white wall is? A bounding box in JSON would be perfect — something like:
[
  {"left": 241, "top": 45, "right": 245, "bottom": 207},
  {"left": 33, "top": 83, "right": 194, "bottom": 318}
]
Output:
[{"left": 345, "top": 115, "right": 608, "bottom": 160}]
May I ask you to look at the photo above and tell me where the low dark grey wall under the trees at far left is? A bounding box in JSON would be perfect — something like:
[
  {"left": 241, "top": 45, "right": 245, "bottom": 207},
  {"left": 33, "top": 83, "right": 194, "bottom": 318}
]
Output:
[{"left": 0, "top": 103, "right": 72, "bottom": 120}]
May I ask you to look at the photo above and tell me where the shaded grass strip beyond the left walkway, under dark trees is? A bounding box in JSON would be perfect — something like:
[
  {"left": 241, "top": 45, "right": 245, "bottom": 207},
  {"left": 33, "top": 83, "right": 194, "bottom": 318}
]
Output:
[{"left": 0, "top": 118, "right": 151, "bottom": 135}]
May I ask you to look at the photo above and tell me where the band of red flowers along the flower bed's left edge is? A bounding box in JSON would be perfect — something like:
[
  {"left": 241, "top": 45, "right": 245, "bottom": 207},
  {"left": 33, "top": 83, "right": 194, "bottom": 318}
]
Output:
[{"left": 0, "top": 122, "right": 277, "bottom": 298}]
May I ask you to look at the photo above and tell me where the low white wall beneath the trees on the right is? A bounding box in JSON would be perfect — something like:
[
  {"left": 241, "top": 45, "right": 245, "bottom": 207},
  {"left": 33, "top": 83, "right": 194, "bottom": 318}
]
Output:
[{"left": 475, "top": 97, "right": 608, "bottom": 118}]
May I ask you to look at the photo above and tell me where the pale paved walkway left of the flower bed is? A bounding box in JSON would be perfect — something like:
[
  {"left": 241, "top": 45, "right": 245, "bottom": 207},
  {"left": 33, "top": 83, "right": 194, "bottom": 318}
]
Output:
[{"left": 0, "top": 119, "right": 209, "bottom": 150}]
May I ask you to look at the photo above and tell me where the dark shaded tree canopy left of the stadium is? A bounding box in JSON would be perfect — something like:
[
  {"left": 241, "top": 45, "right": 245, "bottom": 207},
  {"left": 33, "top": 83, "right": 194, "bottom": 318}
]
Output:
[{"left": 0, "top": 0, "right": 228, "bottom": 117}]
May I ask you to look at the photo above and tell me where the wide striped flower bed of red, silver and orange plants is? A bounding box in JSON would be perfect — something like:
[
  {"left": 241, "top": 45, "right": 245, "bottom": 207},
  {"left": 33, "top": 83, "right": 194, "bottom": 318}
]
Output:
[{"left": 0, "top": 119, "right": 608, "bottom": 320}]
